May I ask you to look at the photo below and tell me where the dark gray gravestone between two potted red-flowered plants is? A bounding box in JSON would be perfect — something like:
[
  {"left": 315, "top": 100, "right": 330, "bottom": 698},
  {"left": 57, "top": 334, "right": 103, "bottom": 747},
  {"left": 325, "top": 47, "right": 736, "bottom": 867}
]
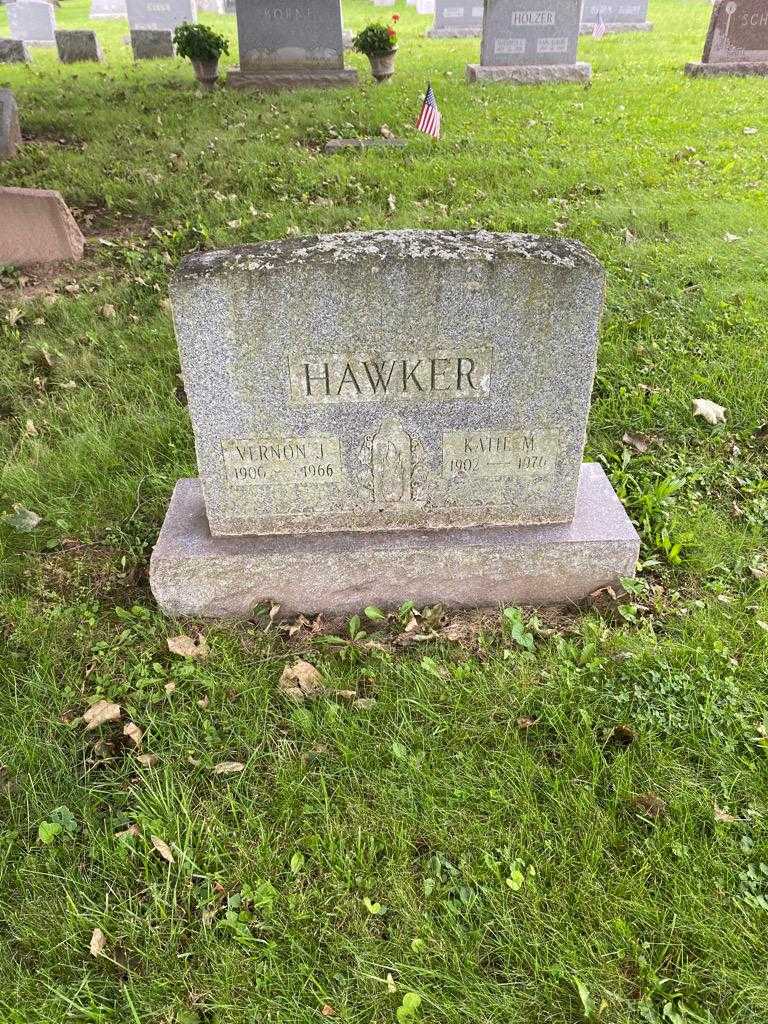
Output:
[{"left": 227, "top": 0, "right": 357, "bottom": 89}]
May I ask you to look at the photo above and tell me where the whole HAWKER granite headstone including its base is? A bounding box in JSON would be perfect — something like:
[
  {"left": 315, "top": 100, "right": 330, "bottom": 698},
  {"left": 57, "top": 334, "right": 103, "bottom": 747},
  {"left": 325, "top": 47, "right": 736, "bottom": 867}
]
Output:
[{"left": 151, "top": 230, "right": 639, "bottom": 616}]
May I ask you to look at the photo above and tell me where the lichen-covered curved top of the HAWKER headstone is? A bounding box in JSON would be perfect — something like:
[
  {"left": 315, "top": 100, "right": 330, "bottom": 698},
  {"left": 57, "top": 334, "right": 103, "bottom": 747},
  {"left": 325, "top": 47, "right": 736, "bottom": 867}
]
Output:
[{"left": 176, "top": 229, "right": 602, "bottom": 278}]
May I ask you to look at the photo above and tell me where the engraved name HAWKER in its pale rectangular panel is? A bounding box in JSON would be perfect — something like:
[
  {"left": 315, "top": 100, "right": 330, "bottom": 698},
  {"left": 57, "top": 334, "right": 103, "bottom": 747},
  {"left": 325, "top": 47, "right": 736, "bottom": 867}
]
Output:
[{"left": 288, "top": 348, "right": 493, "bottom": 404}]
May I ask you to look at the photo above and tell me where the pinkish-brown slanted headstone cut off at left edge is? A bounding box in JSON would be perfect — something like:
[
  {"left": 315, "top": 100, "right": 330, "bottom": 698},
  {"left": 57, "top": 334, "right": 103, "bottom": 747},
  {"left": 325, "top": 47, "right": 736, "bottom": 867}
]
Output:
[{"left": 0, "top": 188, "right": 84, "bottom": 266}]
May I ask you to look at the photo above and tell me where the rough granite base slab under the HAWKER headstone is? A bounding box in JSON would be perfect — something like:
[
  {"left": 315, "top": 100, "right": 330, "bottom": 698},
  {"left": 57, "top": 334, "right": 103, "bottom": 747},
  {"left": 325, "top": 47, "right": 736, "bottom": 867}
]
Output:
[{"left": 150, "top": 463, "right": 640, "bottom": 618}]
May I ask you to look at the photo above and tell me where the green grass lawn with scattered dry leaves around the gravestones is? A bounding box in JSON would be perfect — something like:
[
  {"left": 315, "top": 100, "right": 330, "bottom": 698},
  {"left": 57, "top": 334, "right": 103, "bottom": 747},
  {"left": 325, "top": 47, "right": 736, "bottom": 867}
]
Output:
[{"left": 0, "top": 0, "right": 768, "bottom": 1024}]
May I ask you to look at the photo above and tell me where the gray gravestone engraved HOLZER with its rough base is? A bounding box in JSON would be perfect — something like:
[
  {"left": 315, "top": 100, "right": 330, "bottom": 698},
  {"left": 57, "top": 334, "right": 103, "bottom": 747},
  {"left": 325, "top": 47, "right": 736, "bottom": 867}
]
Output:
[{"left": 467, "top": 0, "right": 592, "bottom": 84}]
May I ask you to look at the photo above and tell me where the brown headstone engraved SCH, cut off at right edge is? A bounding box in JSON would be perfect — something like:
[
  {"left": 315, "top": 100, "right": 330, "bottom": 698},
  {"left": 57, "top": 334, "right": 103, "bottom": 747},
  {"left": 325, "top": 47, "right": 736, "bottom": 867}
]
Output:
[{"left": 685, "top": 0, "right": 768, "bottom": 78}]
